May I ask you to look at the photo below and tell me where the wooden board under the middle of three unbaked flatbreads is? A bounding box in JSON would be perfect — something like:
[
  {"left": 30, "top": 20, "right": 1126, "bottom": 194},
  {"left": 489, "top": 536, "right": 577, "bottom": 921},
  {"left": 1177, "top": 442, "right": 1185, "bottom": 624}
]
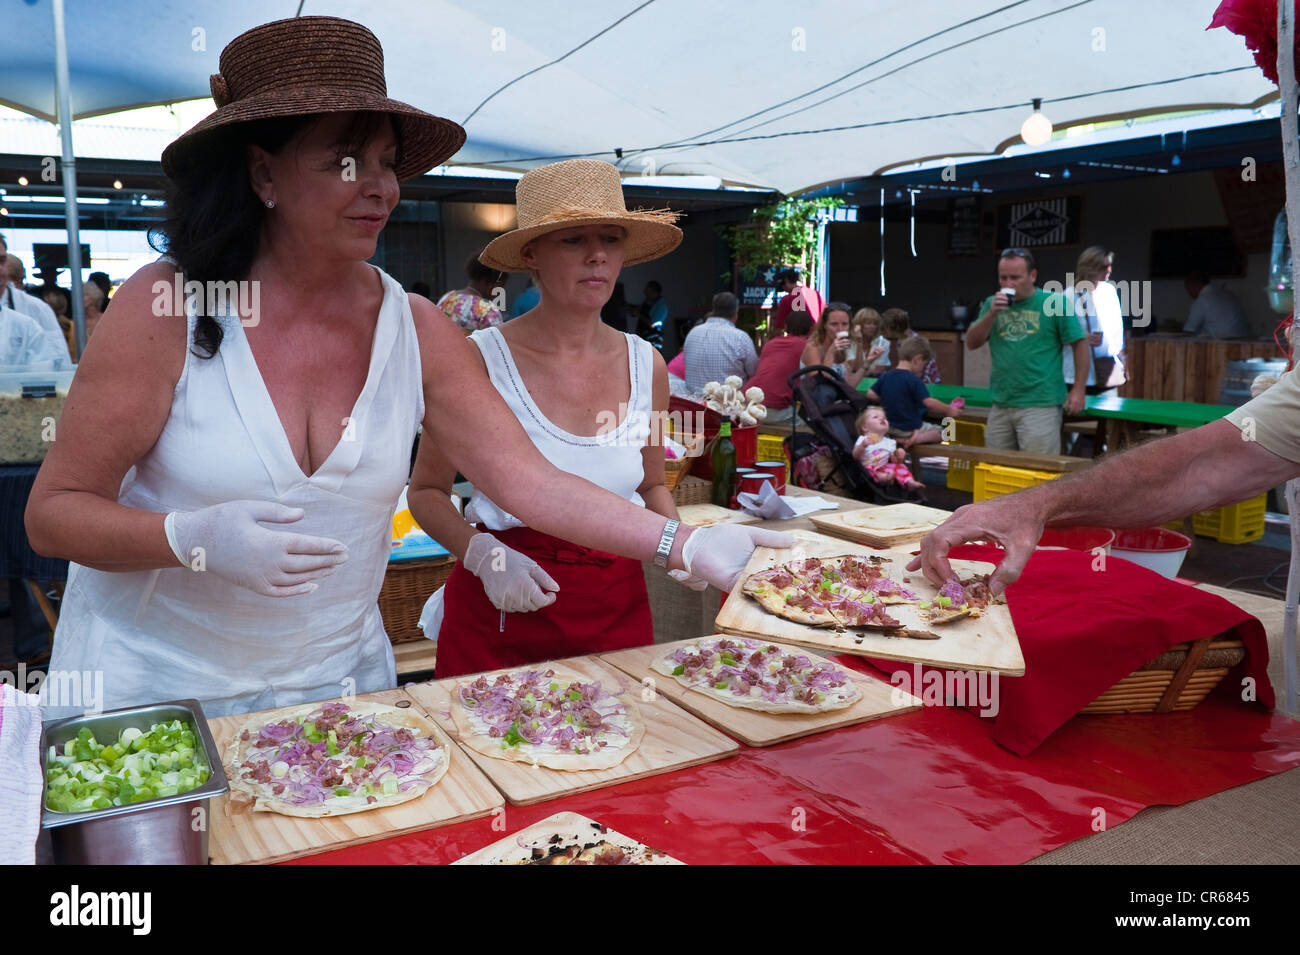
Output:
[{"left": 406, "top": 656, "right": 740, "bottom": 806}]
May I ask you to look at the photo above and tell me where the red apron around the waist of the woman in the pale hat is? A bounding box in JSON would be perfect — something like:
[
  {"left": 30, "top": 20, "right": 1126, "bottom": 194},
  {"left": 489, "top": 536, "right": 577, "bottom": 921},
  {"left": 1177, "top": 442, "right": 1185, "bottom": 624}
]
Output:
[{"left": 434, "top": 528, "right": 654, "bottom": 680}]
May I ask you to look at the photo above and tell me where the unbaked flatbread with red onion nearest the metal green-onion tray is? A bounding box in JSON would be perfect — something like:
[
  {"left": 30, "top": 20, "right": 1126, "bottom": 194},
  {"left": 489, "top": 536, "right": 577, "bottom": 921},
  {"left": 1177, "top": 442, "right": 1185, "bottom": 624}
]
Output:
[{"left": 225, "top": 700, "right": 451, "bottom": 817}]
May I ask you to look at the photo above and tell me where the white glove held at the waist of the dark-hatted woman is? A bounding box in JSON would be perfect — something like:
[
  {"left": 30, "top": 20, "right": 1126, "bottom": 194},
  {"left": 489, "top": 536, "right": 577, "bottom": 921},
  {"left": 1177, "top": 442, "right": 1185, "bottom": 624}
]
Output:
[{"left": 164, "top": 500, "right": 347, "bottom": 596}]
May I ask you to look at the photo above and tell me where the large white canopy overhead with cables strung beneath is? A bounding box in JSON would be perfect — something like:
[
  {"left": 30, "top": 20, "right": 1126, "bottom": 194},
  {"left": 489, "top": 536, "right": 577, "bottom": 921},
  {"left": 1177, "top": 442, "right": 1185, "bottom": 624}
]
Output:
[{"left": 0, "top": 0, "right": 1277, "bottom": 192}]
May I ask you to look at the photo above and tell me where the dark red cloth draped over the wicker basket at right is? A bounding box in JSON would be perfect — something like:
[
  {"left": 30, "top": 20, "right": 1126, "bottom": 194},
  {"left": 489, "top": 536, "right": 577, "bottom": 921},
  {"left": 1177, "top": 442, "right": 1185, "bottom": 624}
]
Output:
[{"left": 872, "top": 546, "right": 1274, "bottom": 756}]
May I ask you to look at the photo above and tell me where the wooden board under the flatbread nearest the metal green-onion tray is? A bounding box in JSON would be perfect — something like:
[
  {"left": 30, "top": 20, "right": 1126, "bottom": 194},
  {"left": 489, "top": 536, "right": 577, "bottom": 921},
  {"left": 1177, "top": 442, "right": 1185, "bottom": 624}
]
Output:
[{"left": 208, "top": 690, "right": 504, "bottom": 865}]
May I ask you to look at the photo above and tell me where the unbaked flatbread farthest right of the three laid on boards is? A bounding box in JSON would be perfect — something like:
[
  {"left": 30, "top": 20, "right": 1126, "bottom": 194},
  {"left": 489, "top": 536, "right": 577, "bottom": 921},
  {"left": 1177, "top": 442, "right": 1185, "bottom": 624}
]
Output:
[{"left": 650, "top": 637, "right": 862, "bottom": 713}]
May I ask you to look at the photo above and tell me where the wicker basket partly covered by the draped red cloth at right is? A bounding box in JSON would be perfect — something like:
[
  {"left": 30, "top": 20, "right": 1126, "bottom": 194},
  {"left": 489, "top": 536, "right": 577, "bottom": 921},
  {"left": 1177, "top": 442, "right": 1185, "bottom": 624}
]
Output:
[{"left": 1079, "top": 637, "right": 1245, "bottom": 713}]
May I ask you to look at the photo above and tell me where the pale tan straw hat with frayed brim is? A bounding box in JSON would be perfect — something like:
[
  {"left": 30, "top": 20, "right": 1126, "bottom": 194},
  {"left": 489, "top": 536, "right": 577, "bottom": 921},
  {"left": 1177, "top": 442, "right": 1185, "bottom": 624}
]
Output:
[{"left": 478, "top": 160, "right": 681, "bottom": 272}]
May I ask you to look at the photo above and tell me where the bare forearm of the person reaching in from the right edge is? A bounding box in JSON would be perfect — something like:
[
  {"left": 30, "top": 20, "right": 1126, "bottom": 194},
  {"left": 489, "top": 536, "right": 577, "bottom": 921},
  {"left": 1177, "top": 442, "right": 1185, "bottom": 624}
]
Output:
[{"left": 1018, "top": 421, "right": 1300, "bottom": 528}]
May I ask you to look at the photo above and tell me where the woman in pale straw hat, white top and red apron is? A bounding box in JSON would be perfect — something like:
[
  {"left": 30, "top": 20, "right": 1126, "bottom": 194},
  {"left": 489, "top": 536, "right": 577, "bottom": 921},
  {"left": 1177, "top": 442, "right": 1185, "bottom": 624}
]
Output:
[{"left": 408, "top": 160, "right": 784, "bottom": 678}]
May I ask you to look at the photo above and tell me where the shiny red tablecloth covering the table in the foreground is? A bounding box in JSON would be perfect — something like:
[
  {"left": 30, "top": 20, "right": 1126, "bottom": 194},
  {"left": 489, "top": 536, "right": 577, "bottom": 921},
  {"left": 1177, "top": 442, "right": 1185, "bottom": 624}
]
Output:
[{"left": 296, "top": 680, "right": 1300, "bottom": 864}]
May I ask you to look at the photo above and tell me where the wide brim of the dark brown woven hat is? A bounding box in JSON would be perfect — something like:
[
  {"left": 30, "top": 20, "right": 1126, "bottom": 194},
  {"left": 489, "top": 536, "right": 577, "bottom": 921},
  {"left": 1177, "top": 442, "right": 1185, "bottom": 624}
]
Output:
[{"left": 163, "top": 88, "right": 465, "bottom": 182}]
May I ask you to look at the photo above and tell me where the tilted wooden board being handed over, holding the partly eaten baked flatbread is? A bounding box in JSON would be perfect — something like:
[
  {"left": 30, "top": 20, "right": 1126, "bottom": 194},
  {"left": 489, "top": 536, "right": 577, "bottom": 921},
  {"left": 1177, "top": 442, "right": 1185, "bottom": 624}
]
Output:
[{"left": 714, "top": 534, "right": 1024, "bottom": 677}]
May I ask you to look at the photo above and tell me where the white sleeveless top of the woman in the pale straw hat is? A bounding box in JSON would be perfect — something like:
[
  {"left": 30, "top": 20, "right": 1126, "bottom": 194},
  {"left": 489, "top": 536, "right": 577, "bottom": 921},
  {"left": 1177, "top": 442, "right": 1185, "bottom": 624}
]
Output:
[{"left": 465, "top": 327, "right": 654, "bottom": 530}]
